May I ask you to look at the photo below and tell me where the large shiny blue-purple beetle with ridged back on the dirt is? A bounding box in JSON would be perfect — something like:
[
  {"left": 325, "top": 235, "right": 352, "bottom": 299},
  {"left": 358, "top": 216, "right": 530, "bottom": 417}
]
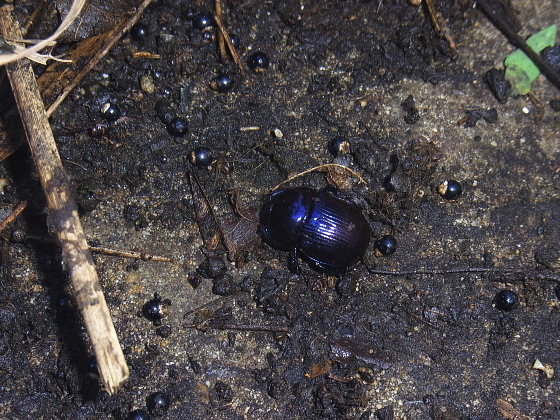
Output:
[{"left": 259, "top": 187, "right": 370, "bottom": 274}]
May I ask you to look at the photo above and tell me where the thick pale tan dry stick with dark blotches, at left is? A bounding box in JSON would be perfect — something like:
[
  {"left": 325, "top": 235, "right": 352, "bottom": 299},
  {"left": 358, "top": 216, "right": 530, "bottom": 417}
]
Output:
[{"left": 0, "top": 4, "right": 128, "bottom": 394}]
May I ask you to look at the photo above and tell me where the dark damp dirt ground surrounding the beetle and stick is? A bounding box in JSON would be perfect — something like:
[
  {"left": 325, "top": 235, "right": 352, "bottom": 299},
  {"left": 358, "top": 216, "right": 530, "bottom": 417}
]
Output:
[{"left": 0, "top": 0, "right": 560, "bottom": 420}]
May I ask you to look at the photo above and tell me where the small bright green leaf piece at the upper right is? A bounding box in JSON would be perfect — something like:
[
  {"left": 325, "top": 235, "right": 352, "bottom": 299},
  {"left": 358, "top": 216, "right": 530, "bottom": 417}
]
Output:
[{"left": 504, "top": 25, "right": 557, "bottom": 95}]
